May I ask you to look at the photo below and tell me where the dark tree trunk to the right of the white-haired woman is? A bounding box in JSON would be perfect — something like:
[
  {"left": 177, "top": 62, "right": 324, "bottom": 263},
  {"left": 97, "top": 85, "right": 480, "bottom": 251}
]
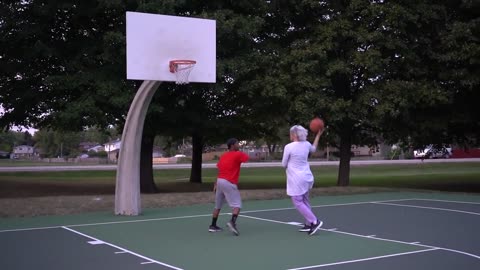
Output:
[{"left": 337, "top": 128, "right": 352, "bottom": 186}]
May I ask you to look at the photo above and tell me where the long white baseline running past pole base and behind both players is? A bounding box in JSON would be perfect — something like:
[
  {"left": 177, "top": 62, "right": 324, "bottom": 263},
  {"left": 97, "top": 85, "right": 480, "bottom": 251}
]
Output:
[{"left": 0, "top": 199, "right": 414, "bottom": 233}]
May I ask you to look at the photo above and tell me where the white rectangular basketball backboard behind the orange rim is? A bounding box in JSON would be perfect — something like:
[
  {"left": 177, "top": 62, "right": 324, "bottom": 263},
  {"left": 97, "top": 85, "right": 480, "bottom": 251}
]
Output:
[{"left": 127, "top": 12, "right": 217, "bottom": 83}]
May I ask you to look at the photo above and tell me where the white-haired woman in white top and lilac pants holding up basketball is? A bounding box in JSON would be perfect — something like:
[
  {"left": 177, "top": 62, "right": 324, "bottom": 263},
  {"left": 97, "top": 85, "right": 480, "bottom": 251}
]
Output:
[{"left": 282, "top": 125, "right": 323, "bottom": 235}]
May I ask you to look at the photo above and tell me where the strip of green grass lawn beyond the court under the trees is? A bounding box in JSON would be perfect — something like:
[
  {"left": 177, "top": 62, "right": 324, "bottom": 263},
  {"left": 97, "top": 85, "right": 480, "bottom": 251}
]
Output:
[{"left": 0, "top": 163, "right": 480, "bottom": 198}]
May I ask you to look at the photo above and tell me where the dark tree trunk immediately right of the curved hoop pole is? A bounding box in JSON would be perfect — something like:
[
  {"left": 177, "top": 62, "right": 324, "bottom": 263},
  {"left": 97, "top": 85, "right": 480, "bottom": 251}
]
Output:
[{"left": 140, "top": 130, "right": 158, "bottom": 193}]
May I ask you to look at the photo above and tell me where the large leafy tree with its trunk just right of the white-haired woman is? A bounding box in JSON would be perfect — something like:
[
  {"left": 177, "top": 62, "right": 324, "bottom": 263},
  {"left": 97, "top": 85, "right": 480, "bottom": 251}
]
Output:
[{"left": 271, "top": 0, "right": 478, "bottom": 185}]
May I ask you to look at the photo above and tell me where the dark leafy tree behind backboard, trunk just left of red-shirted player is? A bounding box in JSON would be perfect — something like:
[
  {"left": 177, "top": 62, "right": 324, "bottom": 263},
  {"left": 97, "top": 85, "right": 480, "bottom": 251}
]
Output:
[{"left": 135, "top": 1, "right": 278, "bottom": 183}]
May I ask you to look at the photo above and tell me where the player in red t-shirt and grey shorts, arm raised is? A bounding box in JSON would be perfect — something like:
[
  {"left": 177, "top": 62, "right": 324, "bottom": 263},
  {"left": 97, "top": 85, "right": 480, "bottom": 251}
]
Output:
[{"left": 208, "top": 138, "right": 248, "bottom": 235}]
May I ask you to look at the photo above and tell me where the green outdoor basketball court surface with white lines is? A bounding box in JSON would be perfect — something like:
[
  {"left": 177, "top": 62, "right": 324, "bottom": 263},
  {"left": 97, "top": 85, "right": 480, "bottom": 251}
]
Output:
[{"left": 0, "top": 192, "right": 480, "bottom": 270}]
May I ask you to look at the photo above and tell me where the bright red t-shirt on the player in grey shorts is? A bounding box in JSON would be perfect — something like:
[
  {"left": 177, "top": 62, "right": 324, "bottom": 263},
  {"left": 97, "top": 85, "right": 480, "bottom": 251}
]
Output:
[{"left": 217, "top": 151, "right": 248, "bottom": 185}]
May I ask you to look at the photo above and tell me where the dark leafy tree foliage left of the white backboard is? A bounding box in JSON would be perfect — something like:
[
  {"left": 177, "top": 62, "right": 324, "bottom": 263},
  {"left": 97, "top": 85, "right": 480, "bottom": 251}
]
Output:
[{"left": 0, "top": 0, "right": 134, "bottom": 130}]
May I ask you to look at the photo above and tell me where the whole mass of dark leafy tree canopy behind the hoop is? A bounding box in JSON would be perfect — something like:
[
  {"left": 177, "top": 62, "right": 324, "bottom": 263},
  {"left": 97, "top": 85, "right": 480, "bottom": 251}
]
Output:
[{"left": 0, "top": 0, "right": 480, "bottom": 188}]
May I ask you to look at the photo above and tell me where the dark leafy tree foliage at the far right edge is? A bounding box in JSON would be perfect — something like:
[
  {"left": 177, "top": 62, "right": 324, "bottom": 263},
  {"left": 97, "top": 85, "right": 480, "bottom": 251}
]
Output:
[{"left": 379, "top": 1, "right": 480, "bottom": 148}]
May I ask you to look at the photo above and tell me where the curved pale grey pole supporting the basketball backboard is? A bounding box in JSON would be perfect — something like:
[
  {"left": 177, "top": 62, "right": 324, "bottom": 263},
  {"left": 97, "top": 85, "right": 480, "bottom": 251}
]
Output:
[{"left": 115, "top": 81, "right": 162, "bottom": 216}]
